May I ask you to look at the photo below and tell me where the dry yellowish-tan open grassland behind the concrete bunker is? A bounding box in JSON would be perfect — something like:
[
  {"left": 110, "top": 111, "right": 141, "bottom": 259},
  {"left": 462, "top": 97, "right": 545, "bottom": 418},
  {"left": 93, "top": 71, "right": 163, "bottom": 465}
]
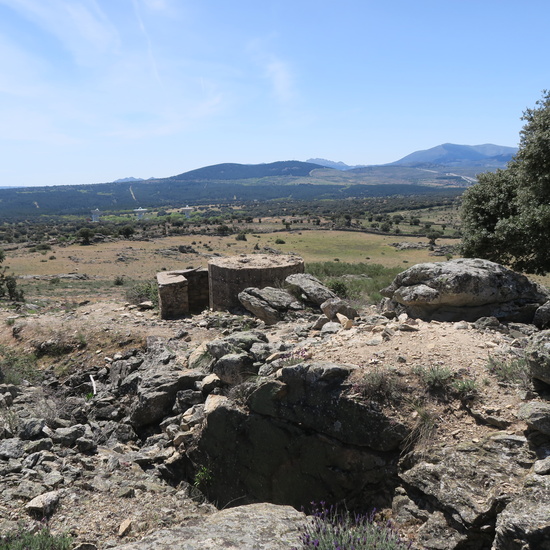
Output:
[{"left": 5, "top": 230, "right": 462, "bottom": 307}]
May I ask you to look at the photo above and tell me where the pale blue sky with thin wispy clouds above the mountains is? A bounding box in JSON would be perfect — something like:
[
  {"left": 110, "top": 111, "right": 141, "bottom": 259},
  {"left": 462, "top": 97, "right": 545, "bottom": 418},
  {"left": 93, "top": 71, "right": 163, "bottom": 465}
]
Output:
[{"left": 0, "top": 0, "right": 550, "bottom": 185}]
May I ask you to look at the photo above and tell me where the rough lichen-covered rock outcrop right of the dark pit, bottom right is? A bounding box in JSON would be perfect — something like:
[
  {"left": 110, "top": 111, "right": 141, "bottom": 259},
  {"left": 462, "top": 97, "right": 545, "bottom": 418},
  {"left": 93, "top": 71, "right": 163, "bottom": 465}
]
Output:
[{"left": 399, "top": 433, "right": 536, "bottom": 550}]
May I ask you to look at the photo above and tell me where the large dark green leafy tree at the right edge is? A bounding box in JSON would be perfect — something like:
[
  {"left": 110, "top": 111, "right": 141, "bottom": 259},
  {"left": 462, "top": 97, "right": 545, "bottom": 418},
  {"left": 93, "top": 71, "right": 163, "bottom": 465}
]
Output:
[{"left": 462, "top": 91, "right": 550, "bottom": 274}]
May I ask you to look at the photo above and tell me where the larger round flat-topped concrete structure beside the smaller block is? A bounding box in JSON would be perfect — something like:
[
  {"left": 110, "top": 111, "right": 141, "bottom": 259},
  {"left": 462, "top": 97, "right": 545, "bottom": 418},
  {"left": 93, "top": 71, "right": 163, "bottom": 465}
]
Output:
[{"left": 208, "top": 254, "right": 304, "bottom": 311}]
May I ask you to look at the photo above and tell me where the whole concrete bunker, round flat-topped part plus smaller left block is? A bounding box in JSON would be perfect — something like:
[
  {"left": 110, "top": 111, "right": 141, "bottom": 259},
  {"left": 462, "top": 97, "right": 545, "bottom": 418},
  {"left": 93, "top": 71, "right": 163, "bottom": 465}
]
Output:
[{"left": 157, "top": 254, "right": 304, "bottom": 319}]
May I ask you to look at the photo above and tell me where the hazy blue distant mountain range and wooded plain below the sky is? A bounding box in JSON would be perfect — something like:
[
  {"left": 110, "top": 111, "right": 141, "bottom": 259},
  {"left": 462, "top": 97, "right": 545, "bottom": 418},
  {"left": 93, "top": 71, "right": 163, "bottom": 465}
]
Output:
[{"left": 0, "top": 144, "right": 516, "bottom": 219}]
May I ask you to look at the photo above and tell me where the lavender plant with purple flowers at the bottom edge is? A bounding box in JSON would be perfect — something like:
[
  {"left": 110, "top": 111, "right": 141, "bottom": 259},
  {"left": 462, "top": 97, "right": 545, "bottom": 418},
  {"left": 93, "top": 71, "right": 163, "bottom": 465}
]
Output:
[{"left": 292, "top": 502, "right": 411, "bottom": 550}]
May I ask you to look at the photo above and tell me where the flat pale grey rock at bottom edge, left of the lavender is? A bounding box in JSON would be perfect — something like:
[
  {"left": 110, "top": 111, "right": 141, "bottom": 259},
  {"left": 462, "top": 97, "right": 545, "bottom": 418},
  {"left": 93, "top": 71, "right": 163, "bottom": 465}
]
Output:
[{"left": 110, "top": 503, "right": 305, "bottom": 550}]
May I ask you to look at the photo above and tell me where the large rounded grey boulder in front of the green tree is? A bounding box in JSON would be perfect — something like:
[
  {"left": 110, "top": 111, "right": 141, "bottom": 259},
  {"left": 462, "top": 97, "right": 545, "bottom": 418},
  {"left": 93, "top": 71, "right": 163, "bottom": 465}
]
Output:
[{"left": 381, "top": 259, "right": 549, "bottom": 323}]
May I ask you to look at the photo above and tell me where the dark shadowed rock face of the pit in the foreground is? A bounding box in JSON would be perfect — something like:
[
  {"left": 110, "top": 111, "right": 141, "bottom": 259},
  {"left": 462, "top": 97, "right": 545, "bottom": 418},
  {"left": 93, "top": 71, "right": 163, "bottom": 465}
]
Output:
[{"left": 188, "top": 362, "right": 409, "bottom": 508}]
